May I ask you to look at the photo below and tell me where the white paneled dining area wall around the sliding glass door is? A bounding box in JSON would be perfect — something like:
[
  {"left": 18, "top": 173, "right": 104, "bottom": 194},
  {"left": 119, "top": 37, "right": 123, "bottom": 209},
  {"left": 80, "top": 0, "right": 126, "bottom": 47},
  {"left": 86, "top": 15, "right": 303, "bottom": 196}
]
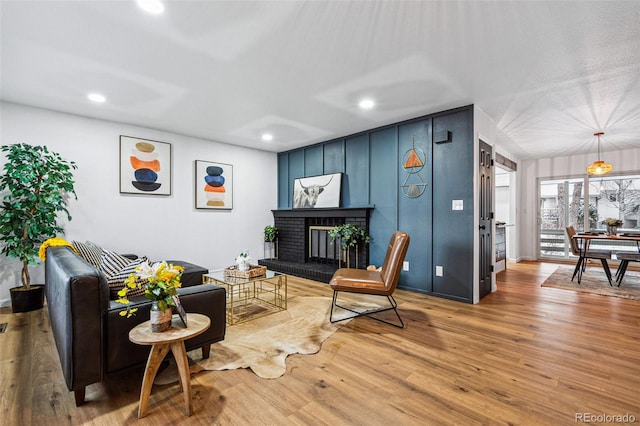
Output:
[{"left": 518, "top": 148, "right": 640, "bottom": 260}]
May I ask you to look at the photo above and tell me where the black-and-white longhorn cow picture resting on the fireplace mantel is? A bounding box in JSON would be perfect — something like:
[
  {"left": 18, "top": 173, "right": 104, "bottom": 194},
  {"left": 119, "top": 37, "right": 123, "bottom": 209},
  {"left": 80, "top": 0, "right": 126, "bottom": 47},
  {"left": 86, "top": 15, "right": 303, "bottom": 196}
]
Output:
[{"left": 293, "top": 173, "right": 342, "bottom": 209}]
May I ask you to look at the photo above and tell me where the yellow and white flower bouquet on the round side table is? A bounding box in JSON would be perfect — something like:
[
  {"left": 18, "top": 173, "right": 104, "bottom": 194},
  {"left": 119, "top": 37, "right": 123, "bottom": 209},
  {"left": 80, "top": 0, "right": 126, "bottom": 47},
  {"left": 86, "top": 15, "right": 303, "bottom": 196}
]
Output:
[{"left": 116, "top": 261, "right": 184, "bottom": 318}]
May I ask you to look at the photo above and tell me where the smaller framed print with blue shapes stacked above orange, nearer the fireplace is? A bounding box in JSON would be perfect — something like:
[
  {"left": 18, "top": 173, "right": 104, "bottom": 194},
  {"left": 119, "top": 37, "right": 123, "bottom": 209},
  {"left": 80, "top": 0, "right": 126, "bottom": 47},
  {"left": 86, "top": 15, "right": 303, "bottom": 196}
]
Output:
[{"left": 194, "top": 160, "right": 233, "bottom": 210}]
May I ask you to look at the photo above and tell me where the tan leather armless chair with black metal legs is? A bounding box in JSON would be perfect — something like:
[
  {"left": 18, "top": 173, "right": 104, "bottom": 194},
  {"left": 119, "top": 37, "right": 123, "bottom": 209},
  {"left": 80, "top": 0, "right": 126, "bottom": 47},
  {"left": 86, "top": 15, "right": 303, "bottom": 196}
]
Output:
[{"left": 329, "top": 231, "right": 409, "bottom": 328}]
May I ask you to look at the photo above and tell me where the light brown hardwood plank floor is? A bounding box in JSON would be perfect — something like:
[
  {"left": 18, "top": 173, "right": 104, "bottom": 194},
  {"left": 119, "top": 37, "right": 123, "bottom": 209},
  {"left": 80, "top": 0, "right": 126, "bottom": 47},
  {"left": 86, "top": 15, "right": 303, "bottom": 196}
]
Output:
[{"left": 0, "top": 262, "right": 640, "bottom": 425}]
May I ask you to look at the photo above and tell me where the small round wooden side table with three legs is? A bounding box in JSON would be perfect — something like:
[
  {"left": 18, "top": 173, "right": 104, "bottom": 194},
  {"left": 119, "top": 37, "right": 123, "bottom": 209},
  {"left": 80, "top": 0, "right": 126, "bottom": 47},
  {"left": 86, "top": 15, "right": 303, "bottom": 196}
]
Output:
[{"left": 129, "top": 314, "right": 211, "bottom": 419}]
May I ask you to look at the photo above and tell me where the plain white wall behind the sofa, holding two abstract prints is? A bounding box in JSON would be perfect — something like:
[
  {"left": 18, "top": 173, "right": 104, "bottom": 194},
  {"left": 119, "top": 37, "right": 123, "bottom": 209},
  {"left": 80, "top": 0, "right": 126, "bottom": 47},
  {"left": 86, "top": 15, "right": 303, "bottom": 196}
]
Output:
[{"left": 0, "top": 102, "right": 277, "bottom": 306}]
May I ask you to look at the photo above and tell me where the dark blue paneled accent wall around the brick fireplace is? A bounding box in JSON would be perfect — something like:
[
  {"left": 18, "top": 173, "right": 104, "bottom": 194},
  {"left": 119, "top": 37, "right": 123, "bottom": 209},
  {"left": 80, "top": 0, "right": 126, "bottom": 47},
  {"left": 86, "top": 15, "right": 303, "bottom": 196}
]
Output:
[{"left": 278, "top": 106, "right": 474, "bottom": 303}]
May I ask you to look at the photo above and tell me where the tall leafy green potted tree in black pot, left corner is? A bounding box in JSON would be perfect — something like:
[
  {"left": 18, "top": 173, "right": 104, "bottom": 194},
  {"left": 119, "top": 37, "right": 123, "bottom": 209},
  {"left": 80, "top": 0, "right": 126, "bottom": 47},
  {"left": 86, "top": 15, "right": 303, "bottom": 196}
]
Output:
[{"left": 0, "top": 143, "right": 77, "bottom": 312}]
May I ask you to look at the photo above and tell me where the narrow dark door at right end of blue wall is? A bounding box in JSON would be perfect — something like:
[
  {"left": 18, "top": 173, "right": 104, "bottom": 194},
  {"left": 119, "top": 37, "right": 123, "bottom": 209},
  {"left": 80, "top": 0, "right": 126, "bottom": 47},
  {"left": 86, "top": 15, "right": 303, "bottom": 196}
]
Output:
[{"left": 478, "top": 141, "right": 493, "bottom": 297}]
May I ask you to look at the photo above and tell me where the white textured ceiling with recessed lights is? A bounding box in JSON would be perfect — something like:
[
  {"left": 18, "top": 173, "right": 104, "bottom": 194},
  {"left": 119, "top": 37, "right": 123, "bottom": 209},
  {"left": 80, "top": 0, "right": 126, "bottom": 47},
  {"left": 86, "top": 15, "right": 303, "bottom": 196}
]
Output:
[{"left": 0, "top": 0, "right": 640, "bottom": 159}]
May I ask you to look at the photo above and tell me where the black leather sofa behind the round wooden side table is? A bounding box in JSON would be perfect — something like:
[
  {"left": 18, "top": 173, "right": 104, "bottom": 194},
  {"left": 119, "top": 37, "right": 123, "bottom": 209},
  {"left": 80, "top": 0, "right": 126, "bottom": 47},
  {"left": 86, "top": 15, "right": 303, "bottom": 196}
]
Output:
[{"left": 45, "top": 247, "right": 226, "bottom": 405}]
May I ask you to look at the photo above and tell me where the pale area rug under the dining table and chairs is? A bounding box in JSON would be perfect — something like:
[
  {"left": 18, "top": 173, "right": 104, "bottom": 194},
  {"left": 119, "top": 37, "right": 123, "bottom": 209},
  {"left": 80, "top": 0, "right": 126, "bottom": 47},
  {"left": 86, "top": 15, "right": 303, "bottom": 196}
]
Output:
[{"left": 542, "top": 265, "right": 640, "bottom": 300}]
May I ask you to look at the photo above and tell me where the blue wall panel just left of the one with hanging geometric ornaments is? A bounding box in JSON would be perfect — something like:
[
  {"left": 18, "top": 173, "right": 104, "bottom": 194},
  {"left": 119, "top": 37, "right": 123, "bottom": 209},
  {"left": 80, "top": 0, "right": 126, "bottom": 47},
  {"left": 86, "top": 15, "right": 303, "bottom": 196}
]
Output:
[{"left": 369, "top": 126, "right": 398, "bottom": 266}]
